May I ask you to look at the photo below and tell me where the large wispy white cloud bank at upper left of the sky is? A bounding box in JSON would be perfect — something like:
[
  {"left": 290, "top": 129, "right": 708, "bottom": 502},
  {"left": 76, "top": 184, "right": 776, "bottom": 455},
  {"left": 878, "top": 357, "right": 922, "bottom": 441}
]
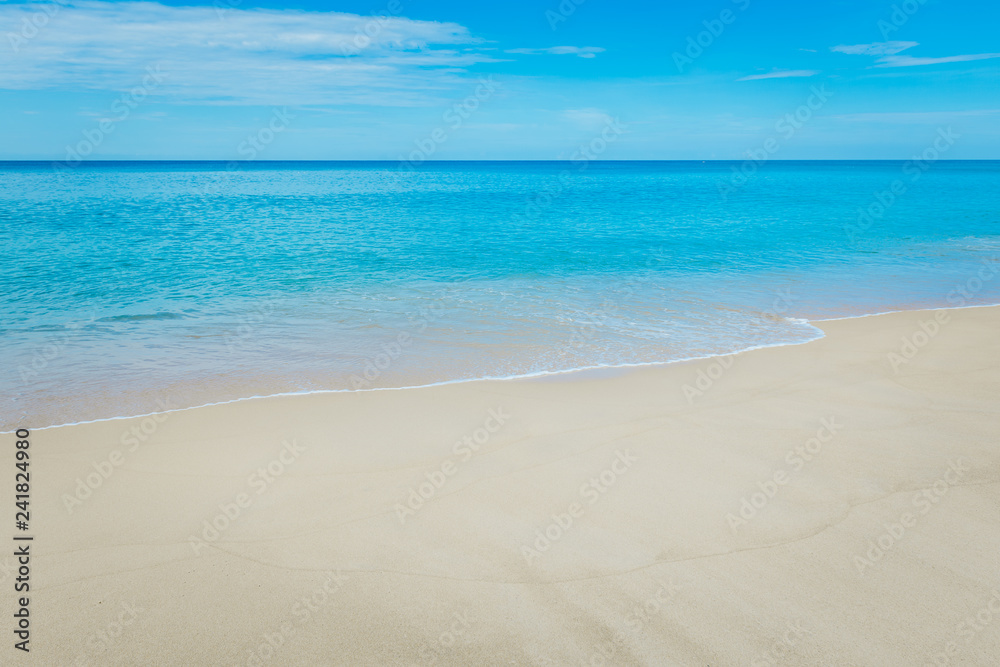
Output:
[{"left": 0, "top": 1, "right": 493, "bottom": 105}]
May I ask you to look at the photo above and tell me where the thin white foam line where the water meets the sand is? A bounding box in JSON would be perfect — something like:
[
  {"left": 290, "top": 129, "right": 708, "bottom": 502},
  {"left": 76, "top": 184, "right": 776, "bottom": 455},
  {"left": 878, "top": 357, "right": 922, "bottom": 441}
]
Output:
[{"left": 11, "top": 304, "right": 1000, "bottom": 435}]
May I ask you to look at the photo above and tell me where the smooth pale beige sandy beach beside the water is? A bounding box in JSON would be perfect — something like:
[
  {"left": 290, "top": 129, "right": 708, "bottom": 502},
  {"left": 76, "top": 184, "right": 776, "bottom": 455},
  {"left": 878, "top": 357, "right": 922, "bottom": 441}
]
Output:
[{"left": 15, "top": 307, "right": 1000, "bottom": 667}]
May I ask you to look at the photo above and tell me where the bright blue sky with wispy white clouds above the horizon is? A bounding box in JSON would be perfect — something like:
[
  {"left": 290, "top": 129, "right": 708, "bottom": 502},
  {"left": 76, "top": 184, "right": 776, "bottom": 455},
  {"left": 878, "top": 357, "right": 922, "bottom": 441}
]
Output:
[{"left": 0, "top": 0, "right": 1000, "bottom": 160}]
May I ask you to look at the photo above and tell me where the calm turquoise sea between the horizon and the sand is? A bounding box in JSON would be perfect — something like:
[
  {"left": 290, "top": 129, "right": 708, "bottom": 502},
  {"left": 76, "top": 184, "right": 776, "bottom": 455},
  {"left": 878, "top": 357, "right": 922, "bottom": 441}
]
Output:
[{"left": 0, "top": 161, "right": 1000, "bottom": 430}]
